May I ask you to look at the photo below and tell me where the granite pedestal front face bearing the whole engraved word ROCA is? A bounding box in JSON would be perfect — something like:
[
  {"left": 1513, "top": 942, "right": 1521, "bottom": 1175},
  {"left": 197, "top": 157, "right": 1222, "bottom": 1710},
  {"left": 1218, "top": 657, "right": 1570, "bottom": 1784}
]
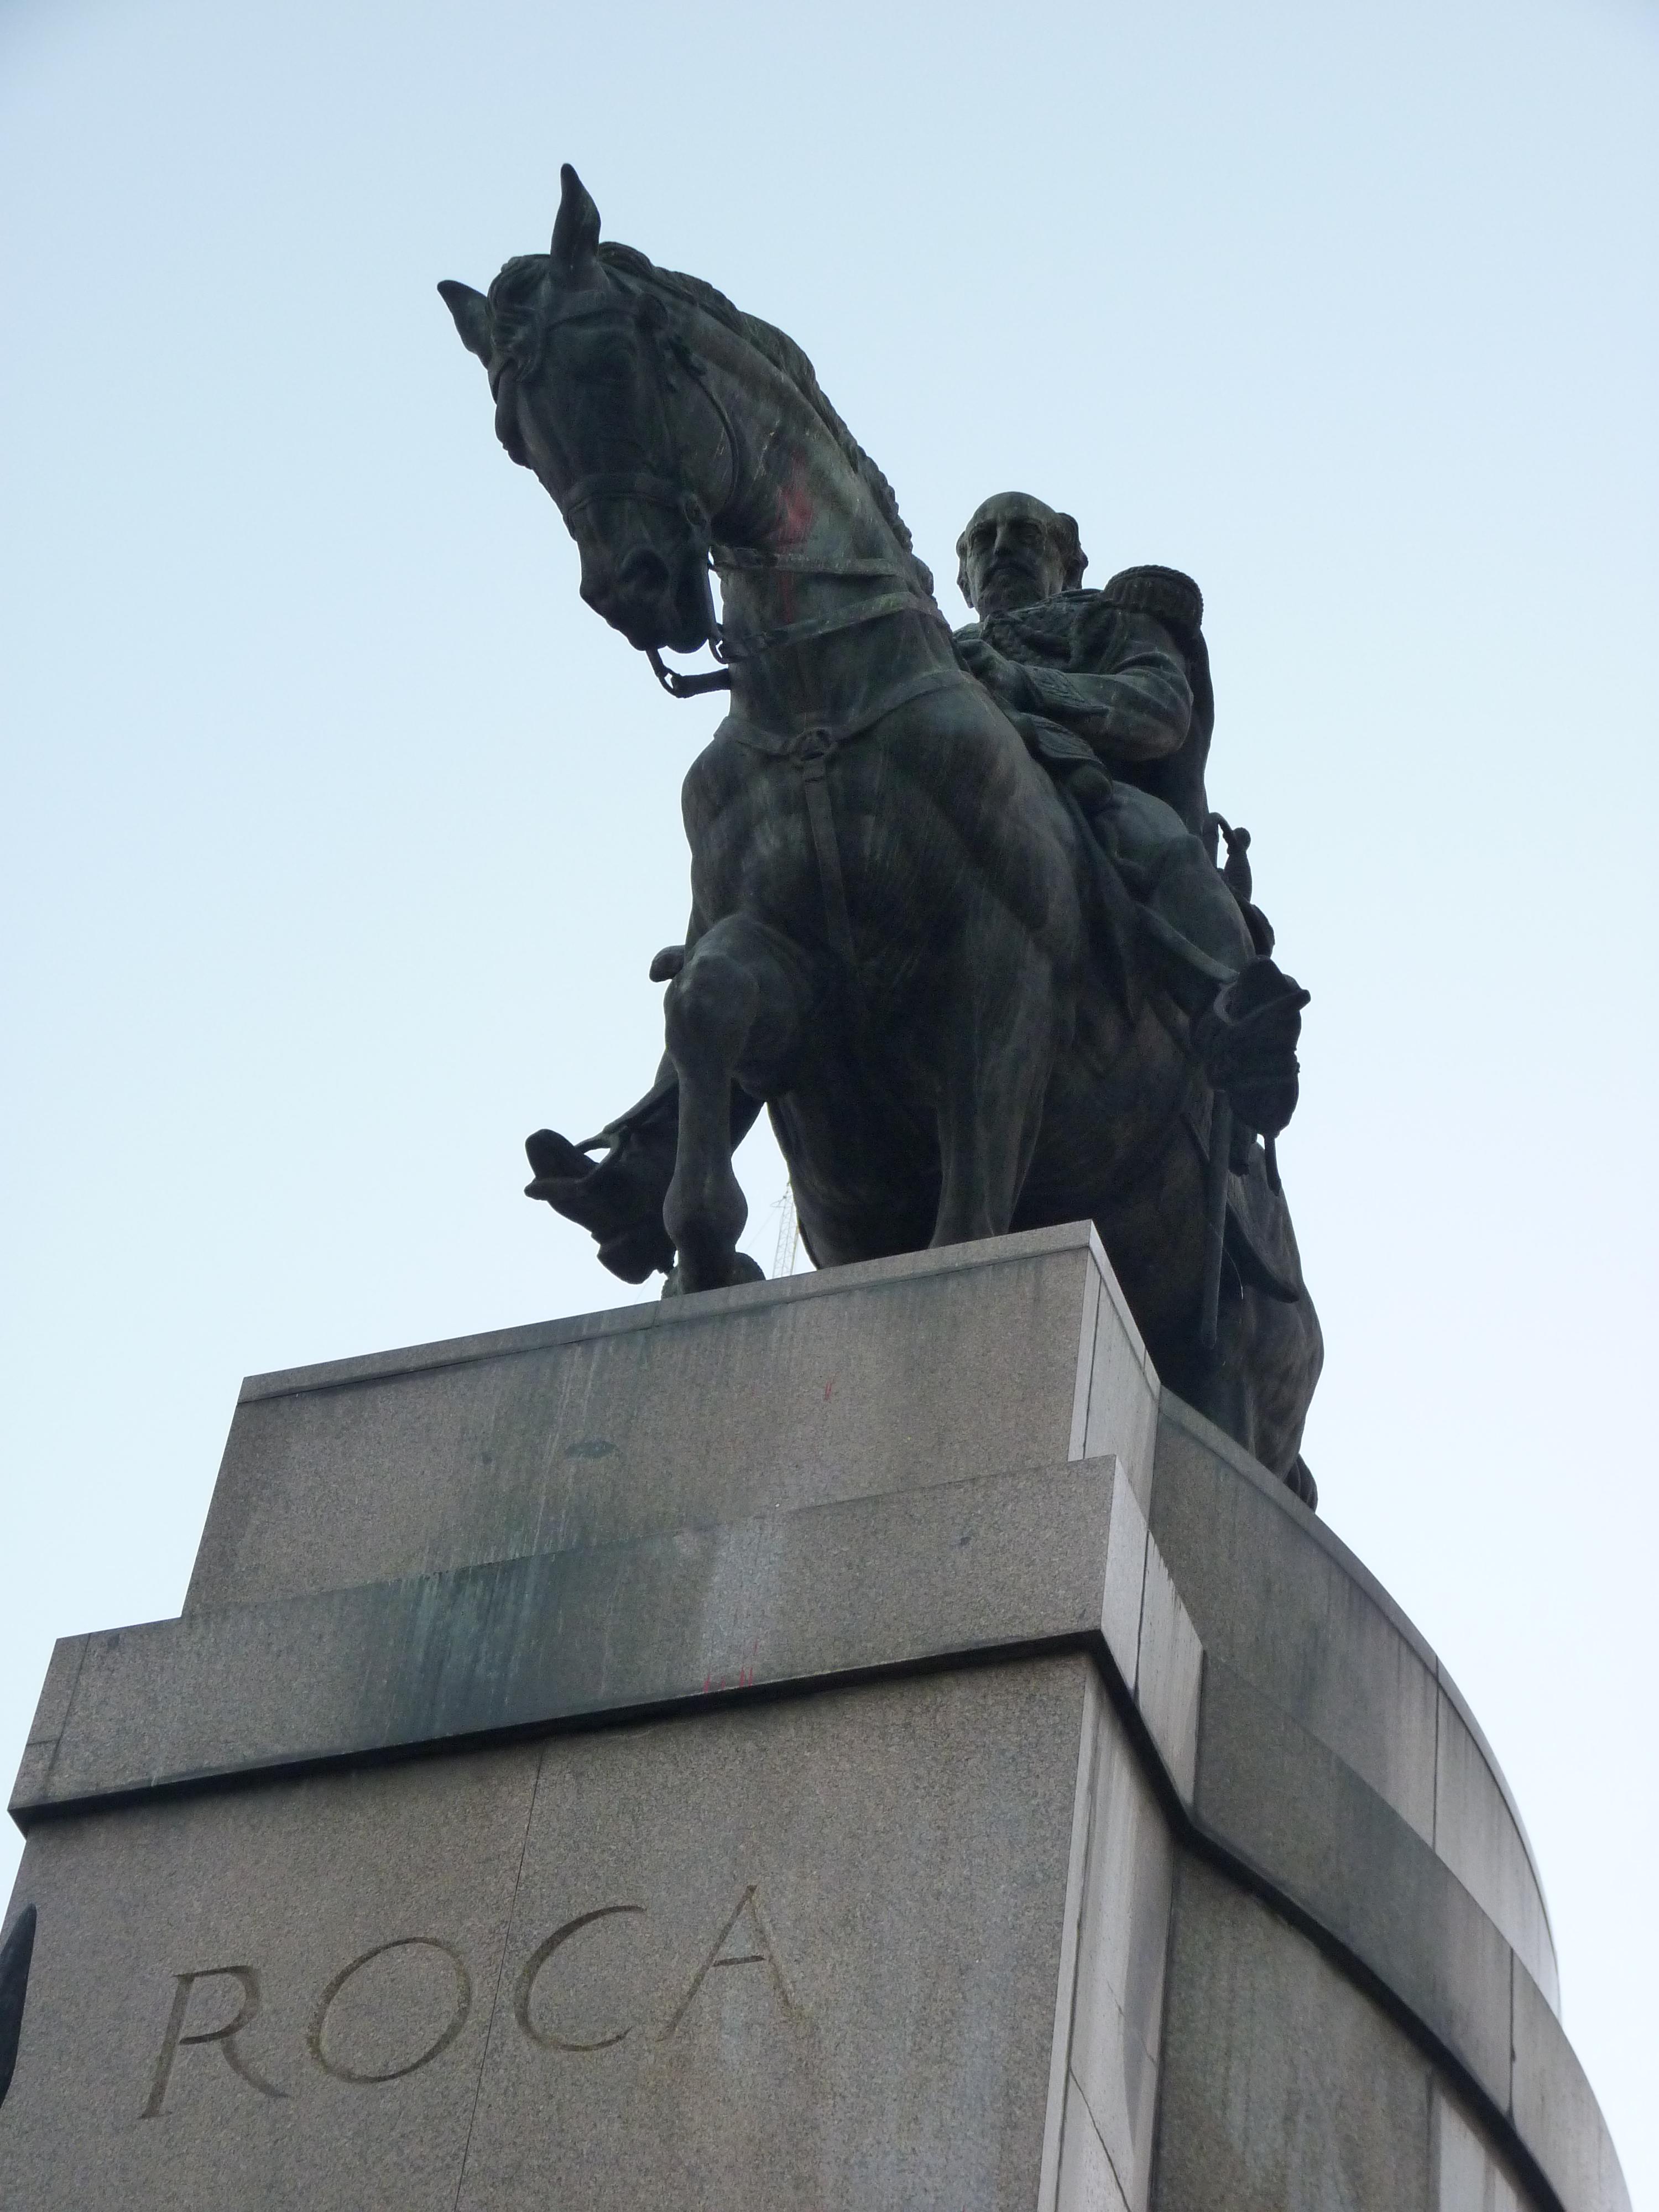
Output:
[{"left": 0, "top": 1657, "right": 1161, "bottom": 2212}]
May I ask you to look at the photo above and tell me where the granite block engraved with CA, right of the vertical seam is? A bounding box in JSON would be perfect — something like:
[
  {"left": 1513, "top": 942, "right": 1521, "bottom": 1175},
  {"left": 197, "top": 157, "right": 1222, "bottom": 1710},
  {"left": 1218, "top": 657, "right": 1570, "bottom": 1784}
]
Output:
[{"left": 458, "top": 1659, "right": 1088, "bottom": 2212}]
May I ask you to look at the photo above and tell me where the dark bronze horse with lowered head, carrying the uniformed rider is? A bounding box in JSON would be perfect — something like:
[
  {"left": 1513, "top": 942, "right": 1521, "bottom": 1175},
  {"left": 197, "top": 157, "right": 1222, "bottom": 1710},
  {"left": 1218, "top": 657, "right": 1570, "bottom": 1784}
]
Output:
[{"left": 440, "top": 168, "right": 1321, "bottom": 1493}]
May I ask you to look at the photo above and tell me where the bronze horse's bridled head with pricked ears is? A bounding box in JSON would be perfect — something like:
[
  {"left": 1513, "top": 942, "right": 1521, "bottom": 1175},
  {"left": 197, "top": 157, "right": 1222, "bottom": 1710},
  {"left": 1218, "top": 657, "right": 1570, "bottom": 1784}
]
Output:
[{"left": 438, "top": 164, "right": 732, "bottom": 653}]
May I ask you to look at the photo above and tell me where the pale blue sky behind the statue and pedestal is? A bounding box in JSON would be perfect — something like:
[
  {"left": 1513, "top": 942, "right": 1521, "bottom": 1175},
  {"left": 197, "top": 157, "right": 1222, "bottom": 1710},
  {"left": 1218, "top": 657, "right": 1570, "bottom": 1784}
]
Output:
[{"left": 0, "top": 0, "right": 1659, "bottom": 2205}]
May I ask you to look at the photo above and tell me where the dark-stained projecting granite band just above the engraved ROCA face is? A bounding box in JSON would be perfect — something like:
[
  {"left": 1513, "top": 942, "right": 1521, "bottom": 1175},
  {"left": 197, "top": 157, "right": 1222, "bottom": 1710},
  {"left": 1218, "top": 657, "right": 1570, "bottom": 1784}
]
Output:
[{"left": 13, "top": 1460, "right": 1150, "bottom": 1825}]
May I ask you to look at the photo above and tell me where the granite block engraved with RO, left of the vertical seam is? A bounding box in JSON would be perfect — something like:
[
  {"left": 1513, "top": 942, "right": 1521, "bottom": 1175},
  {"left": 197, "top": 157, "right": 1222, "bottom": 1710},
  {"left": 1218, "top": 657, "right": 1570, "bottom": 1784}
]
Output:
[{"left": 0, "top": 1750, "right": 538, "bottom": 2212}]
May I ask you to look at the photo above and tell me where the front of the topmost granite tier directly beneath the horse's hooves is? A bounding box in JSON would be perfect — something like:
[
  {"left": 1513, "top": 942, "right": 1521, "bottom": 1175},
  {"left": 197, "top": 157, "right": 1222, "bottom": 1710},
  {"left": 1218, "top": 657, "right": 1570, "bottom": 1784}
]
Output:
[{"left": 186, "top": 1223, "right": 1152, "bottom": 1610}]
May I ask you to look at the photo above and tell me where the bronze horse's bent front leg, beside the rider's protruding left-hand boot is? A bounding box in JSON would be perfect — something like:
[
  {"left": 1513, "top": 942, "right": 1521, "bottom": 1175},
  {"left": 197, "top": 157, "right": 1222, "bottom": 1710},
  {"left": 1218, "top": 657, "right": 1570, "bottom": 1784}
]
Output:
[{"left": 664, "top": 916, "right": 803, "bottom": 1290}]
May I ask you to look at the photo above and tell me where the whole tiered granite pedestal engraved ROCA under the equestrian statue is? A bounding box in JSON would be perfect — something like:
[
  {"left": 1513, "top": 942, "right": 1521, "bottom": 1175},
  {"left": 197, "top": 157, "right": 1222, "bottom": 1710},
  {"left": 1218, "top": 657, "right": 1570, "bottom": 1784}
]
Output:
[{"left": 0, "top": 1228, "right": 1628, "bottom": 2212}]
